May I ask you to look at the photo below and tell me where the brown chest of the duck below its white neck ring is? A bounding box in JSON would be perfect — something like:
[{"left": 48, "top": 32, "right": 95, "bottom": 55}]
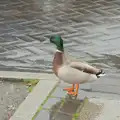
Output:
[{"left": 53, "top": 52, "right": 63, "bottom": 75}]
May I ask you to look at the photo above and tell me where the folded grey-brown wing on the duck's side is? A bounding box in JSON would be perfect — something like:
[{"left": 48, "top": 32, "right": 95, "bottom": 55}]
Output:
[{"left": 69, "top": 62, "right": 102, "bottom": 75}]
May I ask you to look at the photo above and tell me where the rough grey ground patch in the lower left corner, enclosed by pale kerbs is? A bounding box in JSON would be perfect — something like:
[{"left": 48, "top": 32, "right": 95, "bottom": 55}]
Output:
[{"left": 0, "top": 79, "right": 28, "bottom": 120}]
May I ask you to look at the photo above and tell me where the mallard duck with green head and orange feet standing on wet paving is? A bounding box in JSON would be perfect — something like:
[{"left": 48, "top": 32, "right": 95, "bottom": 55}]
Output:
[{"left": 50, "top": 35, "right": 104, "bottom": 96}]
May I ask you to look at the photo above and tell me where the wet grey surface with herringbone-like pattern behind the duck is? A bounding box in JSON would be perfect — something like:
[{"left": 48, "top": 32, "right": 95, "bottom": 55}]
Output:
[{"left": 0, "top": 0, "right": 120, "bottom": 94}]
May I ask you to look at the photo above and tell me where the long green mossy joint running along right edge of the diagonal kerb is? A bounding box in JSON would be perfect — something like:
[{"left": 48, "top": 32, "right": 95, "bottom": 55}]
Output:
[{"left": 32, "top": 84, "right": 58, "bottom": 120}]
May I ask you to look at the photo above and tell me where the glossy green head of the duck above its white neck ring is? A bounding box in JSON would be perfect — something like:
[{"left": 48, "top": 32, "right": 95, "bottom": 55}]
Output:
[{"left": 50, "top": 35, "right": 64, "bottom": 52}]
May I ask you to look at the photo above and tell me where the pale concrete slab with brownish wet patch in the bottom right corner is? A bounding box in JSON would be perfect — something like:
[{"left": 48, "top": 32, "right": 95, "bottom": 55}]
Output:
[{"left": 79, "top": 98, "right": 120, "bottom": 120}]
